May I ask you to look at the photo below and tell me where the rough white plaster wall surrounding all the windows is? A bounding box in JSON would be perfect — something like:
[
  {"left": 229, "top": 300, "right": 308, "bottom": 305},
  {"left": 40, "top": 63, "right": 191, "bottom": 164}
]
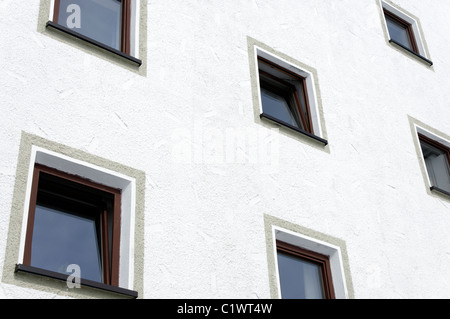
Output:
[{"left": 0, "top": 0, "right": 450, "bottom": 298}]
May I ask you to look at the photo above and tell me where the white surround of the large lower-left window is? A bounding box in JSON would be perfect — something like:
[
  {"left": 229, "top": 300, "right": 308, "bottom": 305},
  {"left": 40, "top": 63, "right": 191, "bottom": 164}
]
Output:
[{"left": 18, "top": 146, "right": 136, "bottom": 290}]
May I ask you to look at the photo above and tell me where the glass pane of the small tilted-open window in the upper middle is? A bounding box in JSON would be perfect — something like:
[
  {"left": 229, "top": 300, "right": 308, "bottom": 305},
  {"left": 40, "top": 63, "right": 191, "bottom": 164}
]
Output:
[{"left": 261, "top": 88, "right": 299, "bottom": 128}]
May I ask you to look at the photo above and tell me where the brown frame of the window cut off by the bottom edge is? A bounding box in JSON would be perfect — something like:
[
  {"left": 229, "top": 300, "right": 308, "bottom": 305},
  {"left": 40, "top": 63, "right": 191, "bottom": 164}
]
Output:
[{"left": 276, "top": 240, "right": 336, "bottom": 299}]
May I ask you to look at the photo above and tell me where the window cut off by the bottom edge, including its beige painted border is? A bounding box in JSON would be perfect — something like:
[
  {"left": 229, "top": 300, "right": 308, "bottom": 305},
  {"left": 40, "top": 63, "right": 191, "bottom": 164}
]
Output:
[{"left": 264, "top": 215, "right": 354, "bottom": 299}]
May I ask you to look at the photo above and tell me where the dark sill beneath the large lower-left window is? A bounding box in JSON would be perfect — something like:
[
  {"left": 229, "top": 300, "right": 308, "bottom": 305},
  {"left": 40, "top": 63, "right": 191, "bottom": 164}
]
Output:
[{"left": 15, "top": 264, "right": 138, "bottom": 298}]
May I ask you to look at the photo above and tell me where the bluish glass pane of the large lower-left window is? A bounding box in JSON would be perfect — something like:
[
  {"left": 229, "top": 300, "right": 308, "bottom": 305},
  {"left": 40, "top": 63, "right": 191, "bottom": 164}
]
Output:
[{"left": 31, "top": 205, "right": 102, "bottom": 282}]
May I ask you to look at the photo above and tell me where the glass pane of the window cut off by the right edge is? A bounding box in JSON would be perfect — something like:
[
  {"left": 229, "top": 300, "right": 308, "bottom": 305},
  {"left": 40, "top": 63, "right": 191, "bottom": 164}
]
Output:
[{"left": 421, "top": 142, "right": 450, "bottom": 192}]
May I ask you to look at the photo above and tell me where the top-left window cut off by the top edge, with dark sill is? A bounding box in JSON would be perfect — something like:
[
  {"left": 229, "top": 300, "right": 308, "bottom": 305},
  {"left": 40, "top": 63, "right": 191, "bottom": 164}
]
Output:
[{"left": 47, "top": 0, "right": 142, "bottom": 65}]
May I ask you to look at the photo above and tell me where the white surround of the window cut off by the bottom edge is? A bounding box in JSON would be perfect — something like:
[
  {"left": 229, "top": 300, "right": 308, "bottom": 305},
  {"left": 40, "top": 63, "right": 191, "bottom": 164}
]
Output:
[{"left": 272, "top": 225, "right": 348, "bottom": 299}]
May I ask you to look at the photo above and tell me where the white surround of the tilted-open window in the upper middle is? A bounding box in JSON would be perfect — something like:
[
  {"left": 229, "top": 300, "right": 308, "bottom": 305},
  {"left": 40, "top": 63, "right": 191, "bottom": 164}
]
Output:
[{"left": 254, "top": 45, "right": 323, "bottom": 137}]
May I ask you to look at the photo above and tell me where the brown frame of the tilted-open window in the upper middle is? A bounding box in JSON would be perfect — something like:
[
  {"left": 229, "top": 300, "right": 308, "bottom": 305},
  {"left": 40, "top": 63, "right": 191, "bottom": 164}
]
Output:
[{"left": 258, "top": 56, "right": 314, "bottom": 135}]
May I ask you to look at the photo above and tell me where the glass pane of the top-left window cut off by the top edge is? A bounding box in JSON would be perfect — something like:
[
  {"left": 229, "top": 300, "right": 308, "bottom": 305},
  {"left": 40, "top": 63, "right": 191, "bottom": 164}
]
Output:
[{"left": 58, "top": 0, "right": 122, "bottom": 50}]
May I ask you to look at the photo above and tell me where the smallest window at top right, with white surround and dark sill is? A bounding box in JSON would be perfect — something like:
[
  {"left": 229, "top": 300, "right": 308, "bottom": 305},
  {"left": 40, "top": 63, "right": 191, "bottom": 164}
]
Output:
[{"left": 380, "top": 0, "right": 433, "bottom": 66}]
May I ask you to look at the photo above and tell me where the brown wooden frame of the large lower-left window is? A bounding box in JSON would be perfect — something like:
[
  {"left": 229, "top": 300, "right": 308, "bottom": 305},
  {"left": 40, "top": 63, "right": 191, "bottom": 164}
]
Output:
[{"left": 23, "top": 164, "right": 121, "bottom": 287}]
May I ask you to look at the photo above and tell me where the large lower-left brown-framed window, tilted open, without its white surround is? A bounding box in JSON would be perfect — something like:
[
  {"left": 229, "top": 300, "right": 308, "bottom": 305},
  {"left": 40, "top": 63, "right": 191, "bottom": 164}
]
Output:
[{"left": 23, "top": 164, "right": 121, "bottom": 286}]
